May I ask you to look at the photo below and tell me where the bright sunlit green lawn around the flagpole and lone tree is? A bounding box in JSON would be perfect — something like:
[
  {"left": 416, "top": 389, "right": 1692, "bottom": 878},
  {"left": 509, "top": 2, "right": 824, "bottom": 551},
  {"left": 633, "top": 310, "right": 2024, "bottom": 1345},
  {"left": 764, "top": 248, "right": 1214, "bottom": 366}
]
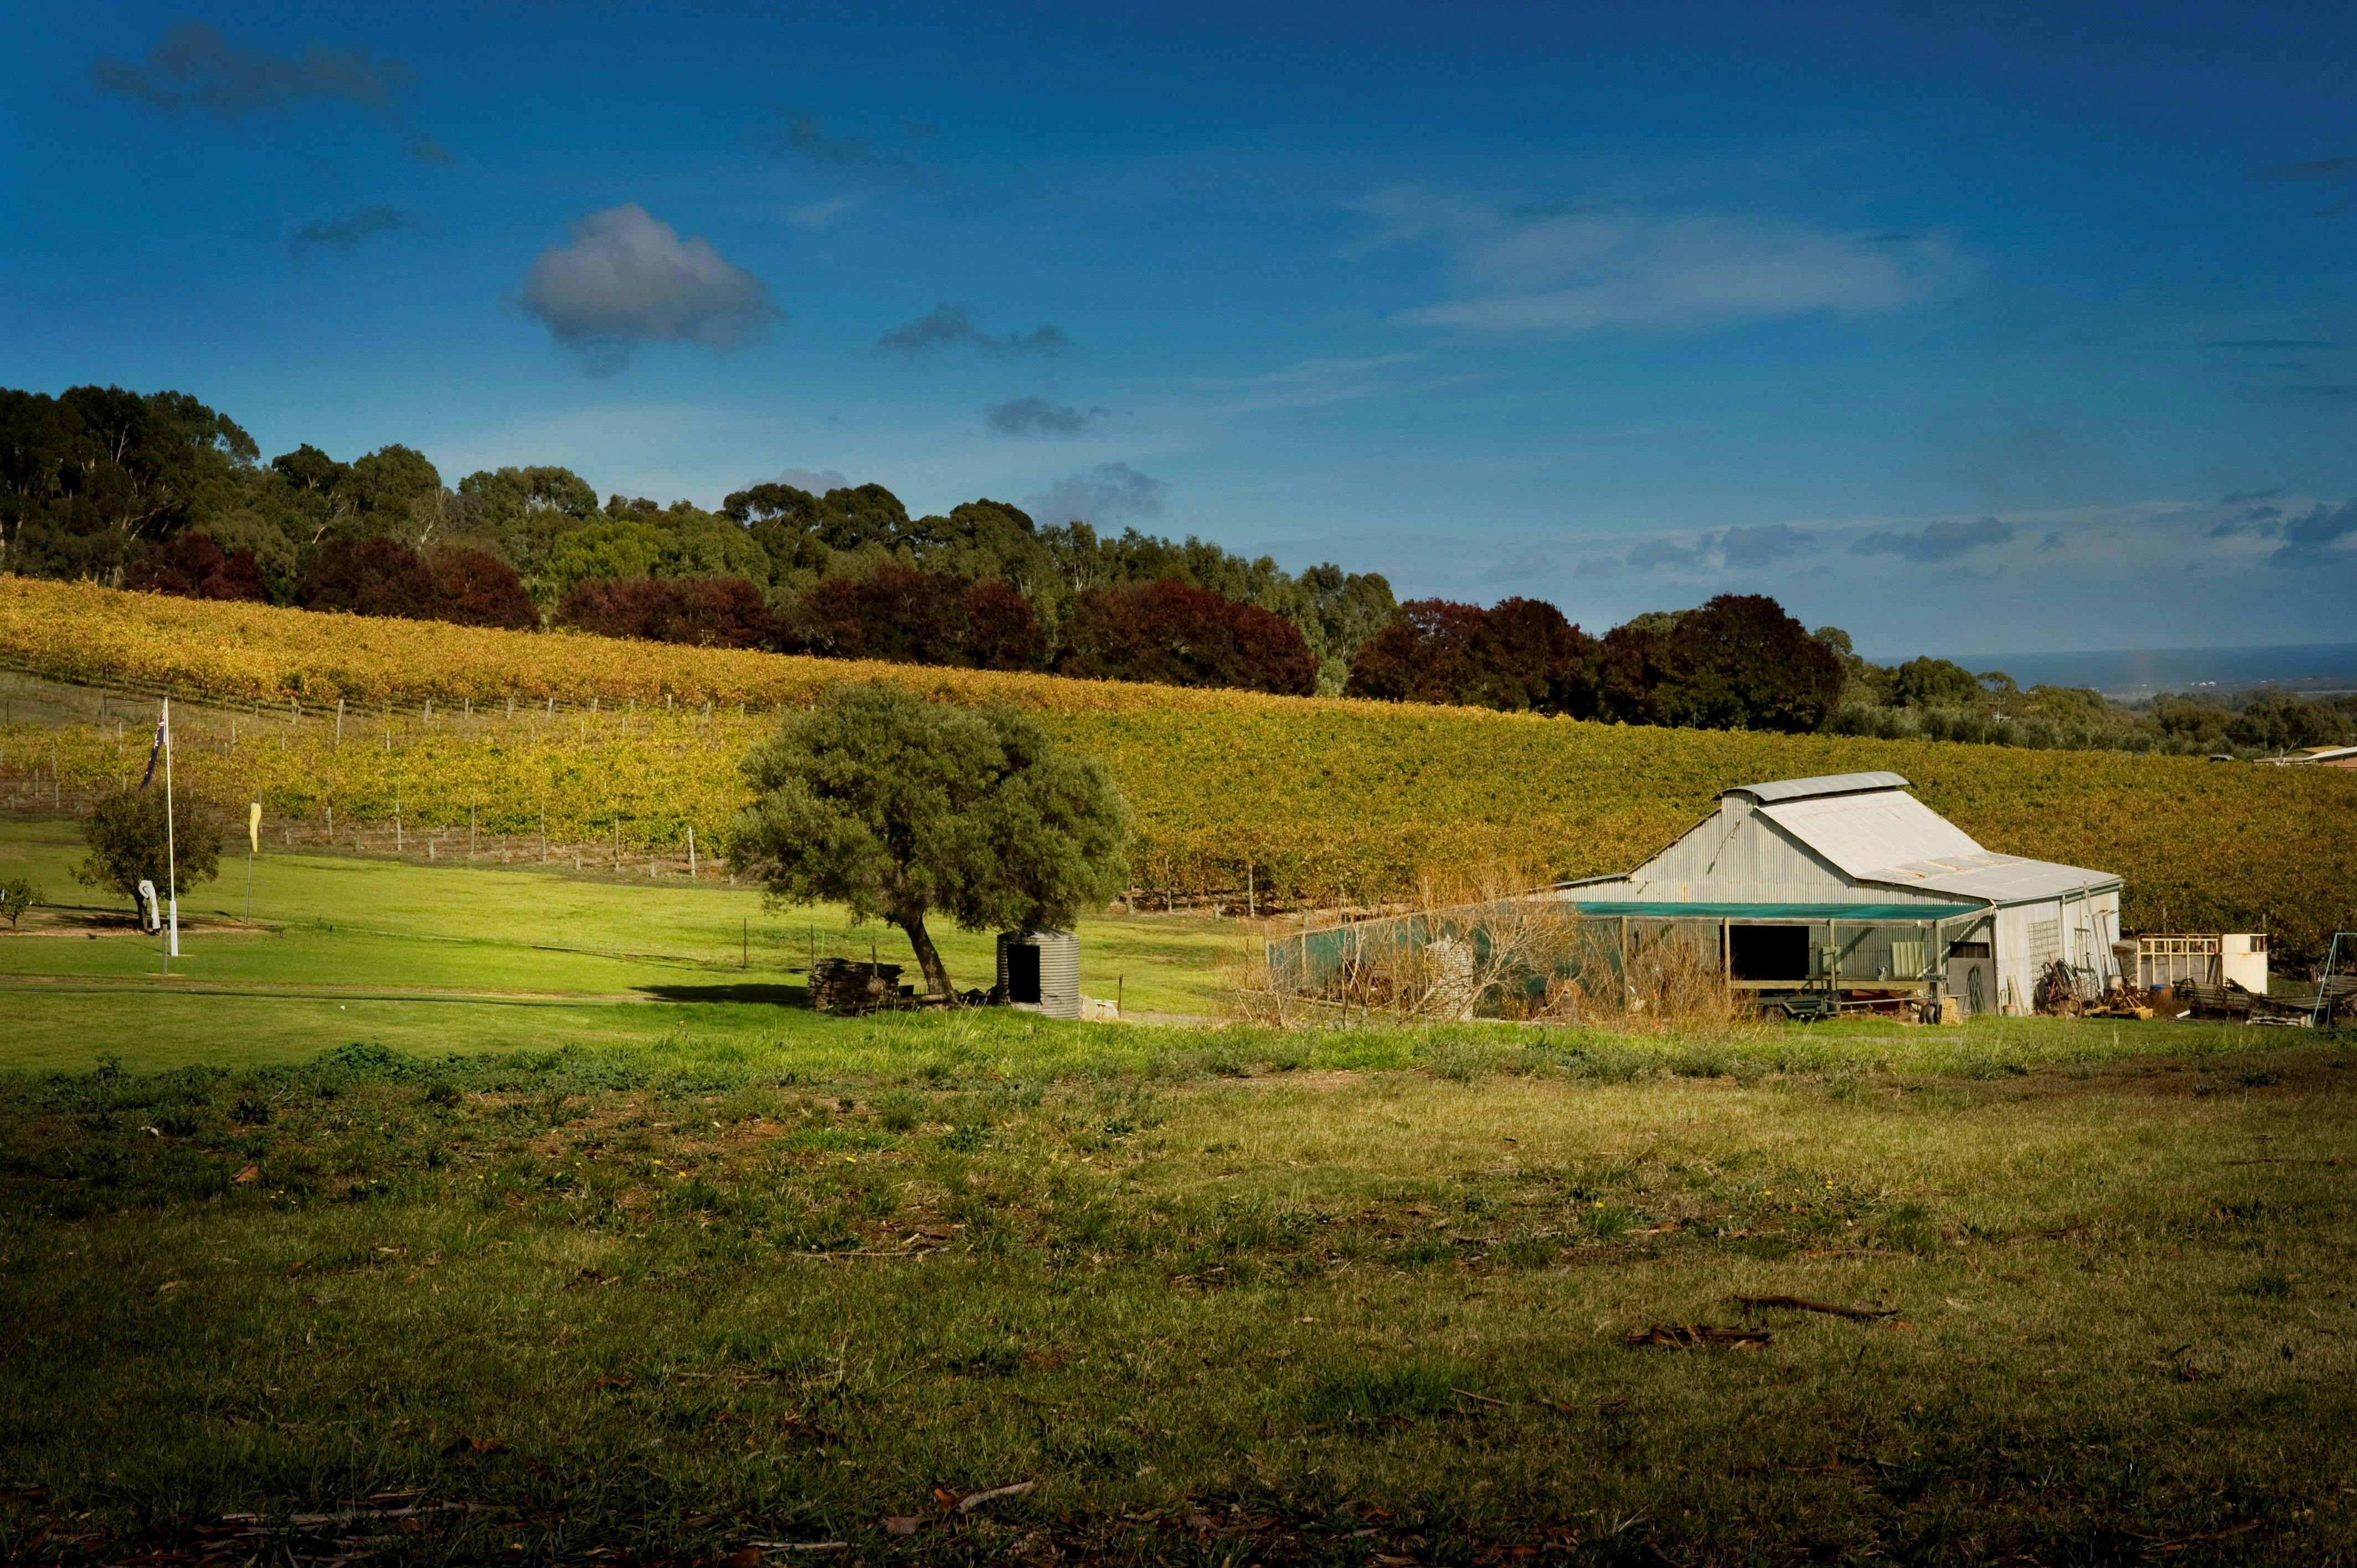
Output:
[{"left": 0, "top": 818, "right": 1247, "bottom": 1066}]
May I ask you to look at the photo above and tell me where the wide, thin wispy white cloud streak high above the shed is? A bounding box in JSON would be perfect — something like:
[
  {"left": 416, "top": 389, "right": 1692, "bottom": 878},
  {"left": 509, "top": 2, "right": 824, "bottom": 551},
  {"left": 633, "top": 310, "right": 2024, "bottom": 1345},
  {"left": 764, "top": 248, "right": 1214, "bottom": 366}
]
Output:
[{"left": 1362, "top": 191, "right": 1961, "bottom": 335}]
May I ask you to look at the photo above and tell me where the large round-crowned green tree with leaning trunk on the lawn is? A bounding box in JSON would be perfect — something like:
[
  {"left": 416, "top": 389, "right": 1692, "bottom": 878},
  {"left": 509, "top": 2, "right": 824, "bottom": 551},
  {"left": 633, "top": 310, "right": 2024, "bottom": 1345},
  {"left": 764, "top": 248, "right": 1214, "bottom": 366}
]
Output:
[{"left": 728, "top": 684, "right": 1131, "bottom": 997}]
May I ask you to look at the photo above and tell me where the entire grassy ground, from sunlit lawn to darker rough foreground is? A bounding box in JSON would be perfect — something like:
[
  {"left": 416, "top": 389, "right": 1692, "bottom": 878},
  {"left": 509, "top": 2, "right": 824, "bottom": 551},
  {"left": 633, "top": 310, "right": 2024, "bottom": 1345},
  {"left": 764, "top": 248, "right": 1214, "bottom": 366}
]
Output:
[{"left": 0, "top": 801, "right": 2357, "bottom": 1566}]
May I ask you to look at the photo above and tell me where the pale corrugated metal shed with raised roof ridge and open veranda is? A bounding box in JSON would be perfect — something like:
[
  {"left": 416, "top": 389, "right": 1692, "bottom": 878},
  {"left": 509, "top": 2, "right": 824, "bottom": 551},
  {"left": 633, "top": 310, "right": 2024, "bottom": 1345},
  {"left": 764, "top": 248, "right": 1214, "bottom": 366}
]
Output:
[{"left": 1556, "top": 773, "right": 2121, "bottom": 1014}]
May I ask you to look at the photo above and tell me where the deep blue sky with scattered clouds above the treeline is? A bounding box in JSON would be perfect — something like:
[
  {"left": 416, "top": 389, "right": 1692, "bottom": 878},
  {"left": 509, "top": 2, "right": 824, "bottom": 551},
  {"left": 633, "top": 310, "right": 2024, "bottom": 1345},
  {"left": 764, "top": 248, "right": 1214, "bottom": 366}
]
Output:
[{"left": 0, "top": 2, "right": 2357, "bottom": 656}]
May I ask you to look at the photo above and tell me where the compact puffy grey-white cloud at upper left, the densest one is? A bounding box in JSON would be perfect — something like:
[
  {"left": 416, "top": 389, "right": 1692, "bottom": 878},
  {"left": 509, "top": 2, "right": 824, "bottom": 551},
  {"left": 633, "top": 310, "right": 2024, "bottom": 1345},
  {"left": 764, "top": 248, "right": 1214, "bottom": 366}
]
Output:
[{"left": 523, "top": 203, "right": 785, "bottom": 370}]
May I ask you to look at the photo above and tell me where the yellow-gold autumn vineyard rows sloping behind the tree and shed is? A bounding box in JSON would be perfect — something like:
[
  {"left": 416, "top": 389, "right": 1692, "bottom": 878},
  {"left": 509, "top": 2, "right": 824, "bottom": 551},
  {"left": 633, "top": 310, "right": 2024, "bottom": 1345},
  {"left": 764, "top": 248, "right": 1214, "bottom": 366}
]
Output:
[{"left": 14, "top": 577, "right": 2357, "bottom": 957}]
